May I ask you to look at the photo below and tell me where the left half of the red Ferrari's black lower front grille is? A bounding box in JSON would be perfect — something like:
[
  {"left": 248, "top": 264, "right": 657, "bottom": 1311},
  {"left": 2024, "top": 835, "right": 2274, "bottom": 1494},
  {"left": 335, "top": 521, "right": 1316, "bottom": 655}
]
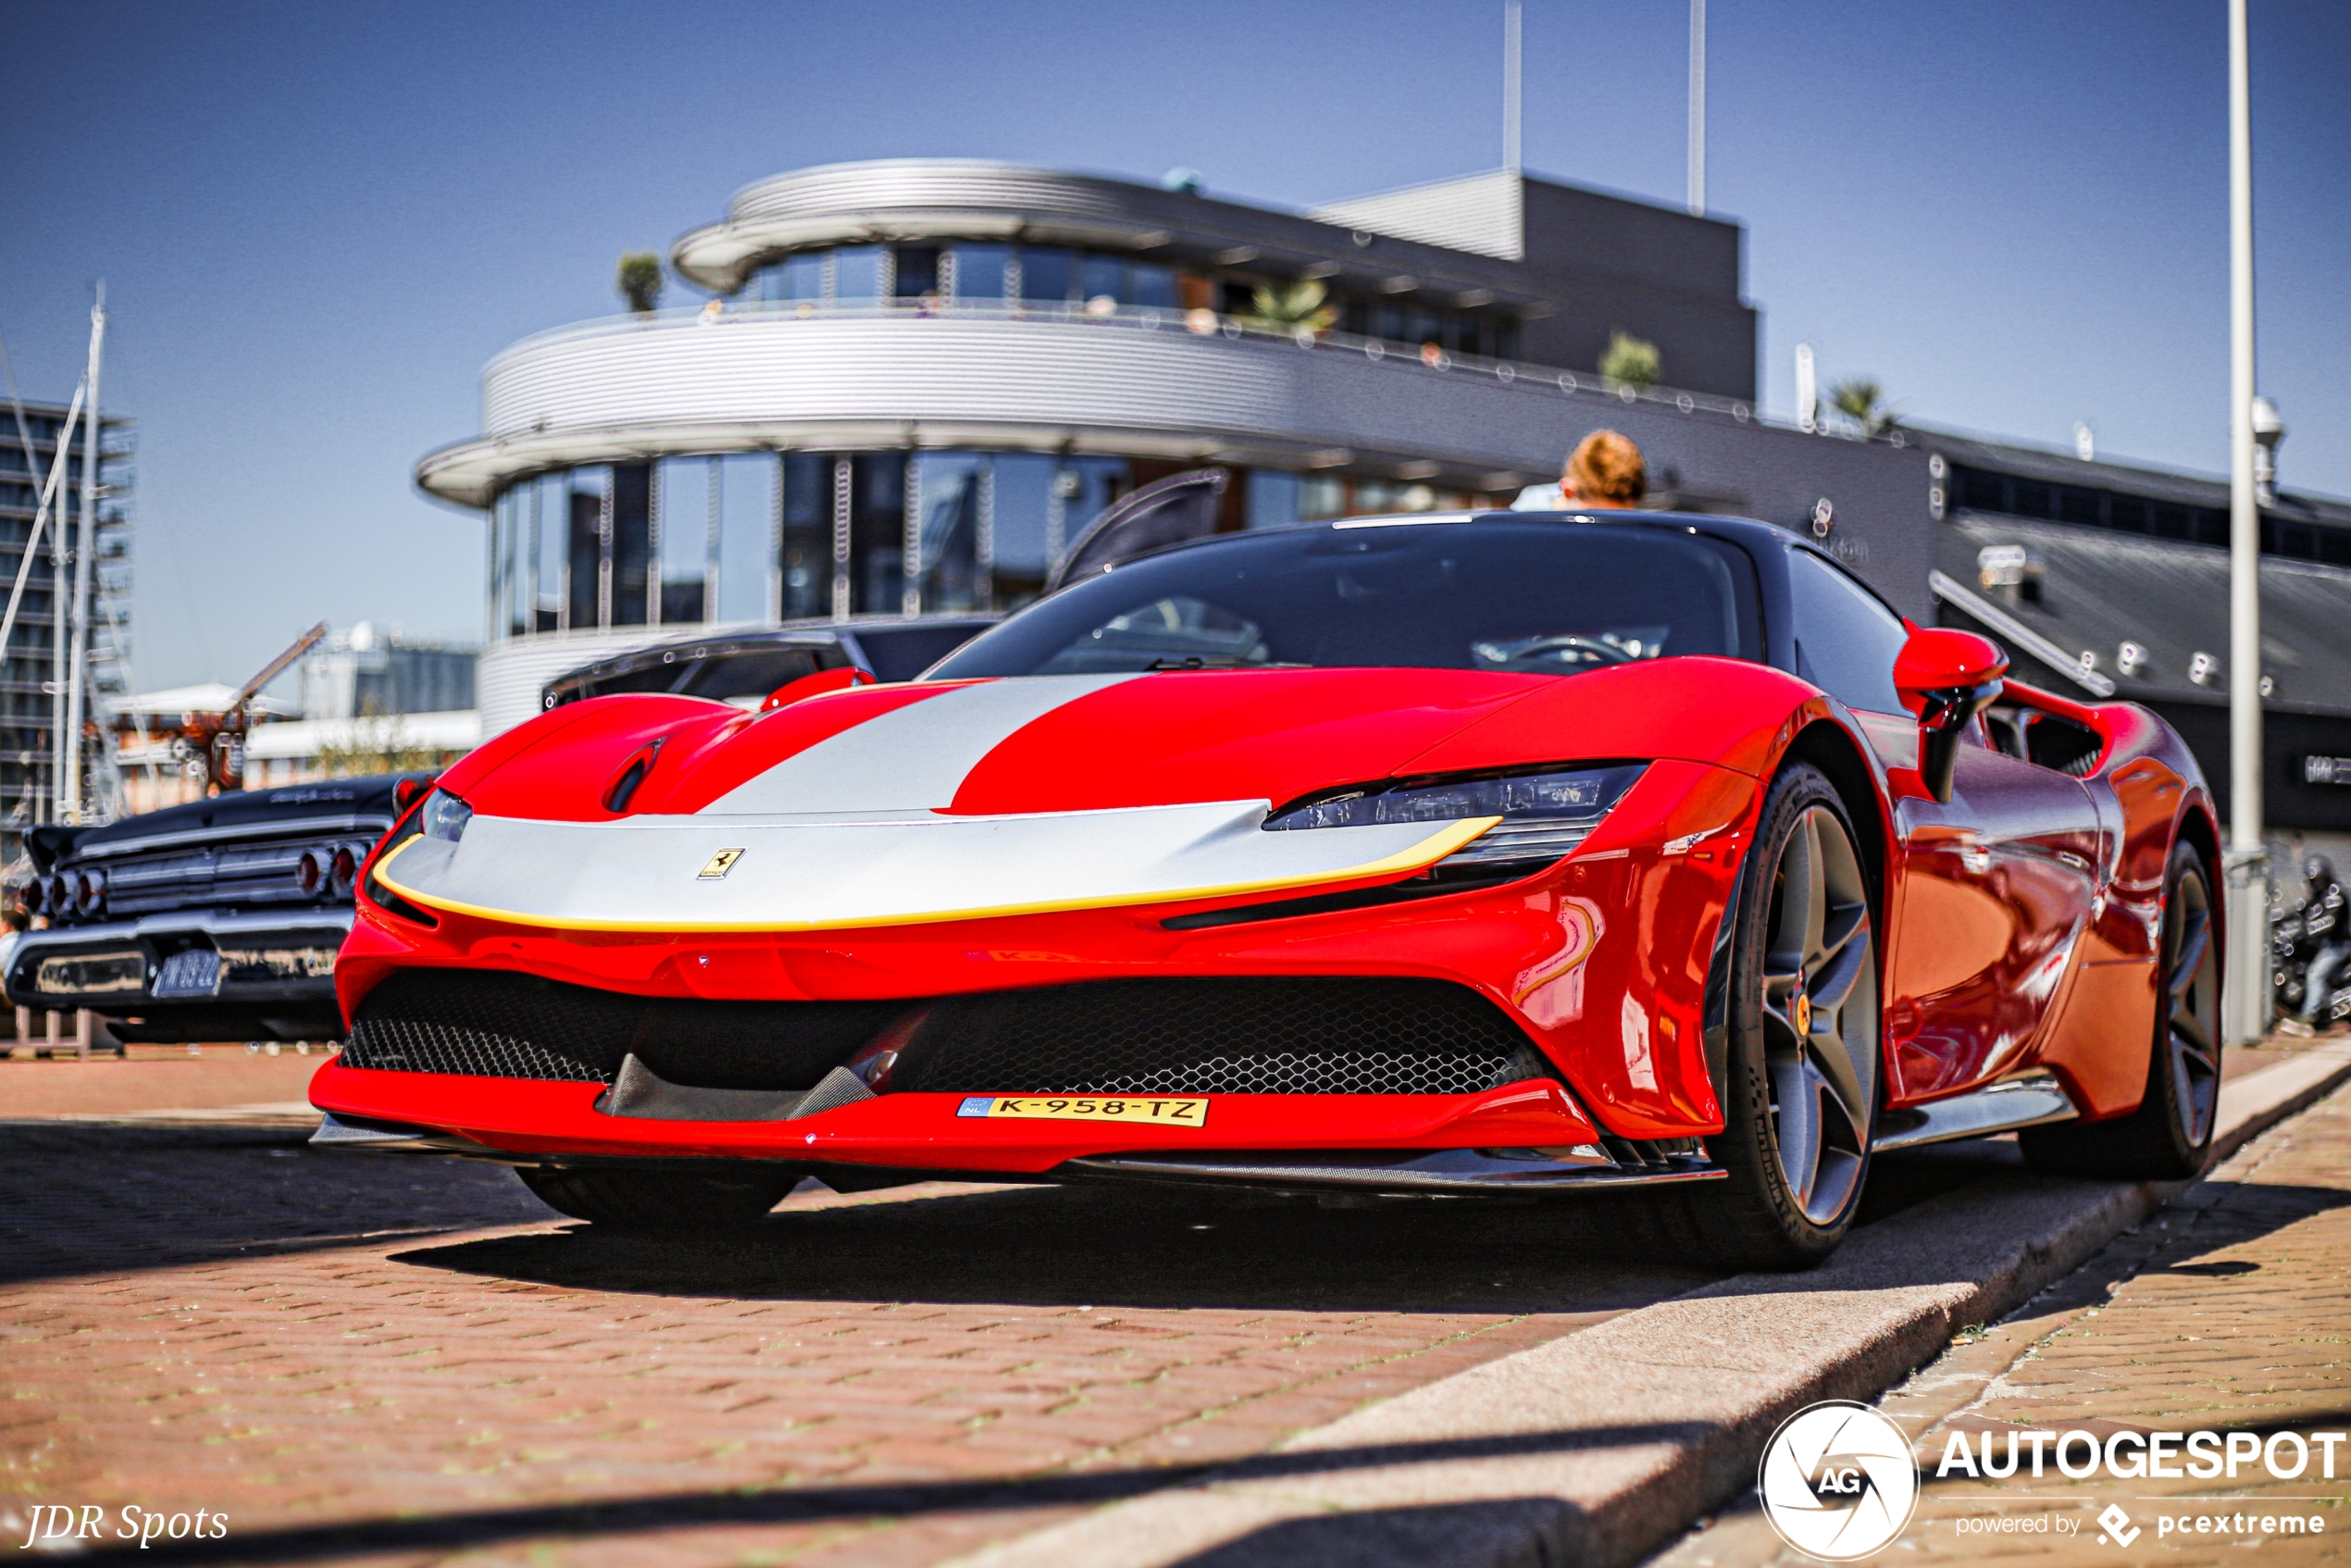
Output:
[{"left": 343, "top": 968, "right": 907, "bottom": 1089}]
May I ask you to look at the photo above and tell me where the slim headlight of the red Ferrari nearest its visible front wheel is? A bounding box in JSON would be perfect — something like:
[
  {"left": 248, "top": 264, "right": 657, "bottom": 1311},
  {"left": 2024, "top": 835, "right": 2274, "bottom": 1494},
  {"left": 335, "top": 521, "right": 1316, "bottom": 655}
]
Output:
[{"left": 1265, "top": 762, "right": 1648, "bottom": 870}]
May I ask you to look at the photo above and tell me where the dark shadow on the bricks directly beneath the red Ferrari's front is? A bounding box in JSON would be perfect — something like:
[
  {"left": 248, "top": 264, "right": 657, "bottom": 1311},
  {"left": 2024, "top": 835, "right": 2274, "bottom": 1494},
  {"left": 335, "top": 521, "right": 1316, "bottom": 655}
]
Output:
[{"left": 395, "top": 1188, "right": 1721, "bottom": 1314}]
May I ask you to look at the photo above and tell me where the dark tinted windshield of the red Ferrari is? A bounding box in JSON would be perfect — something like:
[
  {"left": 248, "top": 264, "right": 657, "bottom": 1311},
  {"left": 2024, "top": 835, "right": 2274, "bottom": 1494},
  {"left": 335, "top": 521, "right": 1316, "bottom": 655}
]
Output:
[{"left": 931, "top": 517, "right": 1763, "bottom": 679}]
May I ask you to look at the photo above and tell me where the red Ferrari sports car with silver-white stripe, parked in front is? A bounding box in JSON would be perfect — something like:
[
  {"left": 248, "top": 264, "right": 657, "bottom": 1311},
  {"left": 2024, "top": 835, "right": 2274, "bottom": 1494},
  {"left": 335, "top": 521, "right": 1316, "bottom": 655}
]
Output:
[{"left": 310, "top": 513, "right": 2221, "bottom": 1267}]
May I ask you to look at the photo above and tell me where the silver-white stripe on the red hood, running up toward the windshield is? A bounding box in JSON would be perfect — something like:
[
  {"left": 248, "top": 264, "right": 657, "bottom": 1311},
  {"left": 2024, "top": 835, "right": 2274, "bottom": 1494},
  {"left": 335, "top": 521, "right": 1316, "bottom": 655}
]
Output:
[{"left": 701, "top": 675, "right": 1136, "bottom": 815}]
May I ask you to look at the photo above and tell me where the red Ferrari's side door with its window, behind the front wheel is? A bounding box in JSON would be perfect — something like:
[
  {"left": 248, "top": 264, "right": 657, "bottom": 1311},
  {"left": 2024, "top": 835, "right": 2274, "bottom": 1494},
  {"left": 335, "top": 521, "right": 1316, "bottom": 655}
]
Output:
[{"left": 1789, "top": 553, "right": 2104, "bottom": 1098}]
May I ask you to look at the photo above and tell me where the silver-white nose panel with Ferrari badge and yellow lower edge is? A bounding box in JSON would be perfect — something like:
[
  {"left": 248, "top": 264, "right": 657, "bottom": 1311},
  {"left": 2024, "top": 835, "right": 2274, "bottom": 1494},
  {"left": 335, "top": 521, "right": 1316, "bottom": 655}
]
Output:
[{"left": 376, "top": 800, "right": 1498, "bottom": 933}]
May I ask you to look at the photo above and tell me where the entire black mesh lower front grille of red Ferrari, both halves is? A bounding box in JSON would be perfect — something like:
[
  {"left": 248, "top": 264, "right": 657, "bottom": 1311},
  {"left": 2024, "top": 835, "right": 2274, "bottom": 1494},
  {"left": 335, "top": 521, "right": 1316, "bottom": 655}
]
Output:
[{"left": 343, "top": 968, "right": 1547, "bottom": 1093}]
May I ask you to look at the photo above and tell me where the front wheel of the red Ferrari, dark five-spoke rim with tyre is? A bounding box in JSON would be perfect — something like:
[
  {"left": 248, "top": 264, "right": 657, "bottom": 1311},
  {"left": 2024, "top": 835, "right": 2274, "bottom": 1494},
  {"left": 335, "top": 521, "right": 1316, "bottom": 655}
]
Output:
[{"left": 1646, "top": 762, "right": 1884, "bottom": 1269}]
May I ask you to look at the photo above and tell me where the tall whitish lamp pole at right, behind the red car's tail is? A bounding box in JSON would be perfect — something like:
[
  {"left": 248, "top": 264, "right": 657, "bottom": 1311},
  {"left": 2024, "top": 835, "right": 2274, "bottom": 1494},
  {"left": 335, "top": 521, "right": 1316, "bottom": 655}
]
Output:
[{"left": 2221, "top": 0, "right": 2271, "bottom": 1046}]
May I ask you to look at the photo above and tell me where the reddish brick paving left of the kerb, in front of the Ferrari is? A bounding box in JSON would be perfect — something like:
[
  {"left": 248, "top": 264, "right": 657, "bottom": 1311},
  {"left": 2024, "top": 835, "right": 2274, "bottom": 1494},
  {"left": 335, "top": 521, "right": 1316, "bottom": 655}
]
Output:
[{"left": 0, "top": 1051, "right": 2313, "bottom": 1565}]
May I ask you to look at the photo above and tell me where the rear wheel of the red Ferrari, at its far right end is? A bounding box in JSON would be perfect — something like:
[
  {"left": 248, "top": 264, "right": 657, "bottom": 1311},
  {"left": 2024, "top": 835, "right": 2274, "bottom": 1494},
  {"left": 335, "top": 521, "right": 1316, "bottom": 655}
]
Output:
[{"left": 2017, "top": 844, "right": 2220, "bottom": 1180}]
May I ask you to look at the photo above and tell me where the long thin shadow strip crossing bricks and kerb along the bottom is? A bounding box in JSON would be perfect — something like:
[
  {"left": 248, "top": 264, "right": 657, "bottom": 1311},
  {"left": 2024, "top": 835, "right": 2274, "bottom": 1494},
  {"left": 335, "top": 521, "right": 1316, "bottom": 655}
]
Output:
[{"left": 36, "top": 1423, "right": 1705, "bottom": 1568}]
